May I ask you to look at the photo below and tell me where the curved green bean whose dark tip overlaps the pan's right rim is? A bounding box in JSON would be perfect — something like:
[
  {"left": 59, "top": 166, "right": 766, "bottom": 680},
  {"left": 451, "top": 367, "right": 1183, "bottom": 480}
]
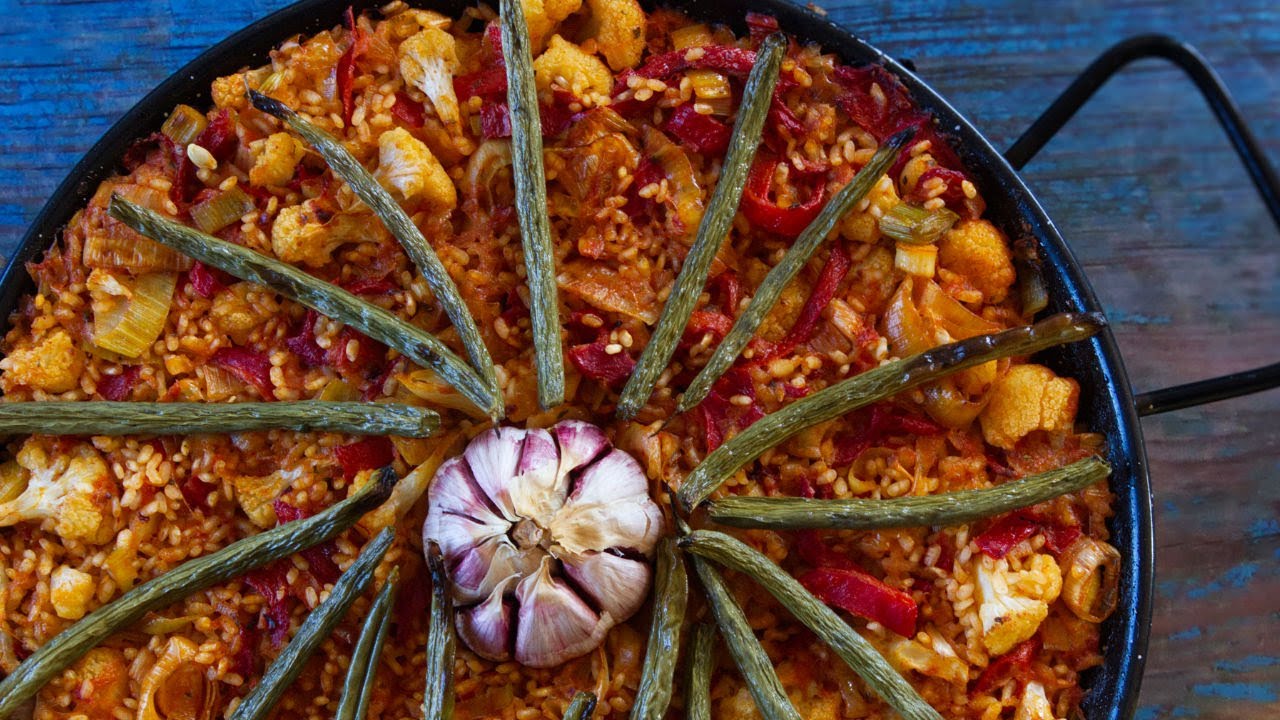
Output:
[{"left": 677, "top": 313, "right": 1106, "bottom": 511}]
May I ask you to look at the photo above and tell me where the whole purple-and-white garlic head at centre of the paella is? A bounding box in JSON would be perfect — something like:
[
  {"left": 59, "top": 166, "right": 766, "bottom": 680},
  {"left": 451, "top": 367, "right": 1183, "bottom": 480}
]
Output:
[{"left": 422, "top": 420, "right": 663, "bottom": 667}]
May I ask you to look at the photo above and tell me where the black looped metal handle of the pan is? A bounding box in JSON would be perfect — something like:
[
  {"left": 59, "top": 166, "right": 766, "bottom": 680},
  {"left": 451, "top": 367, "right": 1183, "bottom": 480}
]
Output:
[{"left": 1005, "top": 35, "right": 1280, "bottom": 415}]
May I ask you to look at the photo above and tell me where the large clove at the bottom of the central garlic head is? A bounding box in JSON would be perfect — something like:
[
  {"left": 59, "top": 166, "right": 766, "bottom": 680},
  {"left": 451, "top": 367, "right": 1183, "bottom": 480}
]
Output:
[{"left": 516, "top": 556, "right": 614, "bottom": 667}]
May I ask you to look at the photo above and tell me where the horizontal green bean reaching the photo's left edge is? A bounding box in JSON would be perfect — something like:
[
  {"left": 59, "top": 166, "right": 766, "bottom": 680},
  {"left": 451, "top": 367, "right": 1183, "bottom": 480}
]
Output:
[{"left": 0, "top": 400, "right": 440, "bottom": 437}]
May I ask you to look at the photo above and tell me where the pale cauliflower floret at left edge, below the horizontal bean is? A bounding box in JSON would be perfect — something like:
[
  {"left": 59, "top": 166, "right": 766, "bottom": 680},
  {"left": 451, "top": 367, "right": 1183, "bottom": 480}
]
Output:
[{"left": 0, "top": 439, "right": 110, "bottom": 541}]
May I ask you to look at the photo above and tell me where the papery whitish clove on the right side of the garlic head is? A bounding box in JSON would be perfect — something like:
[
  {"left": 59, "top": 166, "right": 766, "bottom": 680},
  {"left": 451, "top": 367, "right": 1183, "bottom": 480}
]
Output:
[{"left": 548, "top": 497, "right": 663, "bottom": 556}]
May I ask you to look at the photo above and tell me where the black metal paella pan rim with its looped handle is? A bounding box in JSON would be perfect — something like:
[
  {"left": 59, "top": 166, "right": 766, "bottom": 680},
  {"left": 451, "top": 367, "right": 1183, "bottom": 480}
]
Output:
[{"left": 0, "top": 0, "right": 1280, "bottom": 720}]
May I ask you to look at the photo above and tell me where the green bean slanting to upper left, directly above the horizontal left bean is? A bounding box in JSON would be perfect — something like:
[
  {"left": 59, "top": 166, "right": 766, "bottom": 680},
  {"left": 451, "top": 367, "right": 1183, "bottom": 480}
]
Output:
[{"left": 109, "top": 196, "right": 502, "bottom": 418}]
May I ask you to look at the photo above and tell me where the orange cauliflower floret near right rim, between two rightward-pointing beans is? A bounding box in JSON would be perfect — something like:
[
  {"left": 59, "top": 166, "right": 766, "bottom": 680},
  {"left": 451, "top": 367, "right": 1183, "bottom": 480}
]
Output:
[{"left": 979, "top": 365, "right": 1080, "bottom": 450}]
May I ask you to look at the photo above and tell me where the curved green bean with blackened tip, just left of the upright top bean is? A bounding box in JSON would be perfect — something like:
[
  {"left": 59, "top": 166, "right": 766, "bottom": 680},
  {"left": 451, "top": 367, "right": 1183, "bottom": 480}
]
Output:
[{"left": 248, "top": 90, "right": 504, "bottom": 420}]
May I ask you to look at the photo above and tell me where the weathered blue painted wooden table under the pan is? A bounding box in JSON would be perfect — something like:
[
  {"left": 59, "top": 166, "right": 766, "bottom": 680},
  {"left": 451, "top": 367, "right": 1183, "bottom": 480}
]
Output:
[{"left": 0, "top": 0, "right": 1280, "bottom": 720}]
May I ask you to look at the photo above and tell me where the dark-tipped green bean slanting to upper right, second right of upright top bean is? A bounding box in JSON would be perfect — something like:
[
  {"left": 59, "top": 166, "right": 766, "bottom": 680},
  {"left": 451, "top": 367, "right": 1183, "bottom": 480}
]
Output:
[{"left": 676, "top": 128, "right": 915, "bottom": 413}]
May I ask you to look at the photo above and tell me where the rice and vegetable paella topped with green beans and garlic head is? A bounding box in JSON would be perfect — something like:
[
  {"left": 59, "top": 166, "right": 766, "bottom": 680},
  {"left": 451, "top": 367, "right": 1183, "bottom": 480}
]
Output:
[{"left": 0, "top": 0, "right": 1120, "bottom": 720}]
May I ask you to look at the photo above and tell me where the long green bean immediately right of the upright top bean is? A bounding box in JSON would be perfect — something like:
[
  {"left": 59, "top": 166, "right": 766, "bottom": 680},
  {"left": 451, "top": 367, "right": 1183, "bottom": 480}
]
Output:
[{"left": 618, "top": 33, "right": 787, "bottom": 420}]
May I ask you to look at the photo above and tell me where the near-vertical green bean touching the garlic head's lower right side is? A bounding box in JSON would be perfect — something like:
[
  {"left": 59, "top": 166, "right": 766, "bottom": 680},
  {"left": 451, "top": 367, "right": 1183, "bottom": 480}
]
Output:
[{"left": 631, "top": 537, "right": 689, "bottom": 720}]
